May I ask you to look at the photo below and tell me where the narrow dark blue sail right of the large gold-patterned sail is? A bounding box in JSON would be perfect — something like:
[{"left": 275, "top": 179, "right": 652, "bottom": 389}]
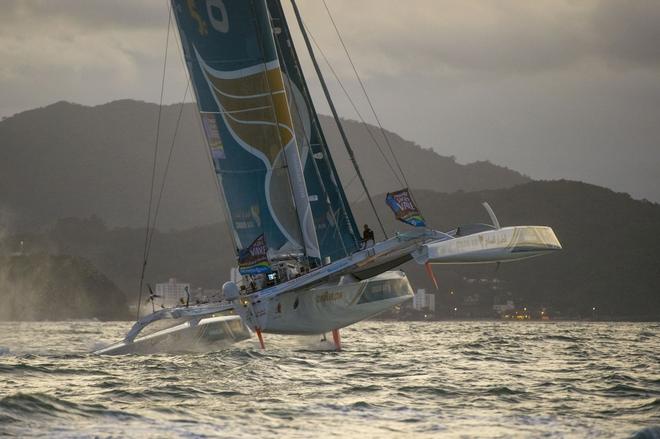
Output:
[{"left": 266, "top": 0, "right": 360, "bottom": 259}]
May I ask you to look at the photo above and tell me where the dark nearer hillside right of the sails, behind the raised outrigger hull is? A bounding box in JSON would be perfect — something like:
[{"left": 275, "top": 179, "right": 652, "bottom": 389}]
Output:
[{"left": 356, "top": 180, "right": 660, "bottom": 320}]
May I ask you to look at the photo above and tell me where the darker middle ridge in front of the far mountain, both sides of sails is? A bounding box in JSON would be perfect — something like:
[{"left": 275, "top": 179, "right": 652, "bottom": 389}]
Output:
[{"left": 6, "top": 181, "right": 660, "bottom": 320}]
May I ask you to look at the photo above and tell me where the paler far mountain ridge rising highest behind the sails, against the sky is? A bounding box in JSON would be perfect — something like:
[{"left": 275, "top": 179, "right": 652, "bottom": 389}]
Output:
[{"left": 0, "top": 100, "right": 529, "bottom": 230}]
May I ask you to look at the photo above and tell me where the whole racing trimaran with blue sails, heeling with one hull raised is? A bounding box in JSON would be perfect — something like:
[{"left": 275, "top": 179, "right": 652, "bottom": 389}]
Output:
[{"left": 96, "top": 0, "right": 561, "bottom": 354}]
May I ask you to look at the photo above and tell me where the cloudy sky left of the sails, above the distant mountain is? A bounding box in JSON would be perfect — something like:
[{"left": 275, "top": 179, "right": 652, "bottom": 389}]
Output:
[{"left": 0, "top": 0, "right": 186, "bottom": 116}]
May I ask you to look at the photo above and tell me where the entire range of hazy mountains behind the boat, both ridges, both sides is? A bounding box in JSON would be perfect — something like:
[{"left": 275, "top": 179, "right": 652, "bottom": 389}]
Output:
[{"left": 0, "top": 101, "right": 660, "bottom": 320}]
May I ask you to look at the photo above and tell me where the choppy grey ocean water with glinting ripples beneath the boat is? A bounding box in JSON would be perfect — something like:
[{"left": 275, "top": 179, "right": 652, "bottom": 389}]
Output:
[{"left": 0, "top": 321, "right": 660, "bottom": 438}]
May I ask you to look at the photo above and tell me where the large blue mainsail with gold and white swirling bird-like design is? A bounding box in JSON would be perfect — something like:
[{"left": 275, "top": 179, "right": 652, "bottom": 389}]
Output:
[{"left": 172, "top": 0, "right": 321, "bottom": 258}]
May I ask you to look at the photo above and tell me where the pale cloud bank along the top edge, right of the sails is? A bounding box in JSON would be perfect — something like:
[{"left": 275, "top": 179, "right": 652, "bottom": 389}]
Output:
[{"left": 292, "top": 0, "right": 660, "bottom": 78}]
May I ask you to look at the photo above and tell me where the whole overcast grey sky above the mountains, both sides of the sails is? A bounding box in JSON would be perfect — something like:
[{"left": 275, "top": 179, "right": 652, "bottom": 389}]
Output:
[{"left": 0, "top": 0, "right": 660, "bottom": 202}]
